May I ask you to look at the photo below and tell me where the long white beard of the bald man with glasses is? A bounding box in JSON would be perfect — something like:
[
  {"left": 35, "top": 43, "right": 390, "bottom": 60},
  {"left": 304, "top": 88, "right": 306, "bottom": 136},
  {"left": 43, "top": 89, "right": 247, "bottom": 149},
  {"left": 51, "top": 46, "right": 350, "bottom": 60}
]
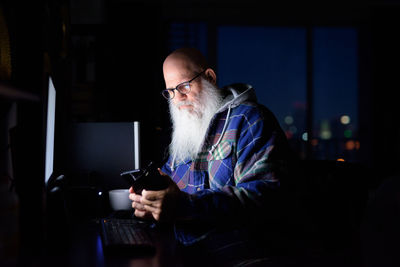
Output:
[{"left": 169, "top": 79, "right": 222, "bottom": 161}]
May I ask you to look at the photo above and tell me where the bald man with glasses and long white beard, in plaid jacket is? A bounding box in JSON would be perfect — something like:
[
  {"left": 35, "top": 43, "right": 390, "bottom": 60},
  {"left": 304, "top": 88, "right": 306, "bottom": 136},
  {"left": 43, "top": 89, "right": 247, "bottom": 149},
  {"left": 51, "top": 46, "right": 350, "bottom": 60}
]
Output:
[{"left": 130, "top": 48, "right": 289, "bottom": 254}]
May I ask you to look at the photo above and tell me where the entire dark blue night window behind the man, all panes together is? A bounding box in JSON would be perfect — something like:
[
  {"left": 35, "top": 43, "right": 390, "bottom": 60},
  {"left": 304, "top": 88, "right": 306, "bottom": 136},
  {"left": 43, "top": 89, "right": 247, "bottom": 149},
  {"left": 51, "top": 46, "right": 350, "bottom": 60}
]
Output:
[{"left": 170, "top": 23, "right": 360, "bottom": 161}]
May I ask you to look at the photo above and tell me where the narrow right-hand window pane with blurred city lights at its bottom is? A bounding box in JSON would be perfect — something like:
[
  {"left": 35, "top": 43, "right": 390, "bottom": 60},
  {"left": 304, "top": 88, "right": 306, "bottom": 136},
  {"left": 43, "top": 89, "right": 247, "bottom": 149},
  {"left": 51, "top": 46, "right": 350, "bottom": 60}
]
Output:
[{"left": 311, "top": 28, "right": 360, "bottom": 161}]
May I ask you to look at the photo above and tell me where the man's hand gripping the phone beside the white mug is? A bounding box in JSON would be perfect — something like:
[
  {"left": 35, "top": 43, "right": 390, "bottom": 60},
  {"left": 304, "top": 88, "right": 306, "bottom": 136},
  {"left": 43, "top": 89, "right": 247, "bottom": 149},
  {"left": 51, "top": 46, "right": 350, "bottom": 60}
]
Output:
[{"left": 129, "top": 169, "right": 183, "bottom": 222}]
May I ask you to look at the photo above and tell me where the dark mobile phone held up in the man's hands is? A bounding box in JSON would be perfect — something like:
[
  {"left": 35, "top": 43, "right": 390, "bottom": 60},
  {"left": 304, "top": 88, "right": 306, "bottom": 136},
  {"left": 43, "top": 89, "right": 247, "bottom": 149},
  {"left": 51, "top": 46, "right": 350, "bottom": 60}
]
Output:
[{"left": 121, "top": 162, "right": 168, "bottom": 195}]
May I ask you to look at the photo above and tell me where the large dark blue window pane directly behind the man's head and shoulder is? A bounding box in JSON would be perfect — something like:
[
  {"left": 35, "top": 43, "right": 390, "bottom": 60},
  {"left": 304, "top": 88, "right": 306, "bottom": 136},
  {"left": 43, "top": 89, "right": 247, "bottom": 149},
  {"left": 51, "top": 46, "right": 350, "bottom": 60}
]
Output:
[{"left": 217, "top": 26, "right": 307, "bottom": 159}]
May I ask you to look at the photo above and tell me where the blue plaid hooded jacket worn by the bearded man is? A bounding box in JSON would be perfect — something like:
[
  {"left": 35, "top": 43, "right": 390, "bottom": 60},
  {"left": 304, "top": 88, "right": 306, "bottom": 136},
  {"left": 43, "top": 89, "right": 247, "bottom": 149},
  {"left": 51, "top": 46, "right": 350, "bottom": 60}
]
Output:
[{"left": 162, "top": 85, "right": 287, "bottom": 245}]
